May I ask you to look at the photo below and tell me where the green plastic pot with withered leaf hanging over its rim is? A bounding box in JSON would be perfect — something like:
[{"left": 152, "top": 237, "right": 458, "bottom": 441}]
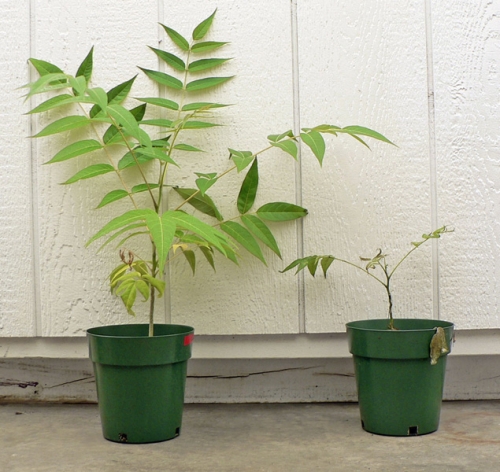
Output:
[{"left": 346, "top": 319, "right": 453, "bottom": 436}]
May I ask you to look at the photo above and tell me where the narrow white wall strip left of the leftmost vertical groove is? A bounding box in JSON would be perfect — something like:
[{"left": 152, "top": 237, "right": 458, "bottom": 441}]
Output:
[{"left": 0, "top": 1, "right": 36, "bottom": 336}]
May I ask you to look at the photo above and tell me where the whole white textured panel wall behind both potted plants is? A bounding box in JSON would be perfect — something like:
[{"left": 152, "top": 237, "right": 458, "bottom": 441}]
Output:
[{"left": 0, "top": 0, "right": 500, "bottom": 337}]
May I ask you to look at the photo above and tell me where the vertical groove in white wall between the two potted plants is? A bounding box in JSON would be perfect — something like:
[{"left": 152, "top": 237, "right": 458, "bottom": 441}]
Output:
[{"left": 290, "top": 0, "right": 306, "bottom": 333}]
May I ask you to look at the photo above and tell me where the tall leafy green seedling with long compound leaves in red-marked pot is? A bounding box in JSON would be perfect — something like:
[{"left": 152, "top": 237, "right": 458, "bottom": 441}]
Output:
[{"left": 23, "top": 12, "right": 389, "bottom": 336}]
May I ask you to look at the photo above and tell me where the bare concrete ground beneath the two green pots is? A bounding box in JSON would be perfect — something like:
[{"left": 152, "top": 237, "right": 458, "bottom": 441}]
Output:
[{"left": 0, "top": 401, "right": 500, "bottom": 472}]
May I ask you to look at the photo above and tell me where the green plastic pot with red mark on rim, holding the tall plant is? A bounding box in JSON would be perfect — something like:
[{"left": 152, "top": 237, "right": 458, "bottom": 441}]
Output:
[{"left": 87, "top": 324, "right": 194, "bottom": 443}]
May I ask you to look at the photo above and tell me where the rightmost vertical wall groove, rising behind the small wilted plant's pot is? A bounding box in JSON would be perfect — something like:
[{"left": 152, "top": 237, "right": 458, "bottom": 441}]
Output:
[{"left": 425, "top": 0, "right": 440, "bottom": 319}]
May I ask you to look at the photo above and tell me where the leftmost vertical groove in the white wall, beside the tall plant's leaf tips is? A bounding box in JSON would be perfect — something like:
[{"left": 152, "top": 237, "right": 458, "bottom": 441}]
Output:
[{"left": 26, "top": 0, "right": 42, "bottom": 336}]
